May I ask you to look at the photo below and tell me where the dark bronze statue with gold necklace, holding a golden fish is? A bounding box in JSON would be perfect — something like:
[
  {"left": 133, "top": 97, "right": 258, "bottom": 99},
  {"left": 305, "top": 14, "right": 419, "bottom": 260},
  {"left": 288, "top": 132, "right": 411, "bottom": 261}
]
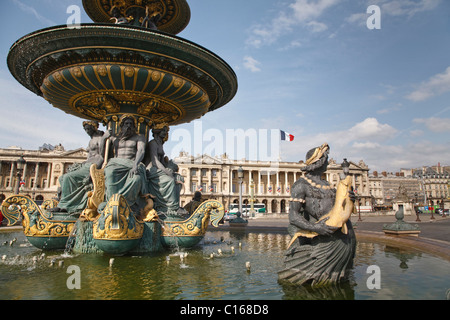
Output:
[{"left": 278, "top": 143, "right": 356, "bottom": 286}]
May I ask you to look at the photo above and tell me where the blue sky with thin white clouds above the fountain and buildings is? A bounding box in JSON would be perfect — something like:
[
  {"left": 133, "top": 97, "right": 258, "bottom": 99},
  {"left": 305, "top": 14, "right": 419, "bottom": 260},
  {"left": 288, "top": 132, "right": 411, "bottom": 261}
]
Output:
[{"left": 0, "top": 0, "right": 450, "bottom": 172}]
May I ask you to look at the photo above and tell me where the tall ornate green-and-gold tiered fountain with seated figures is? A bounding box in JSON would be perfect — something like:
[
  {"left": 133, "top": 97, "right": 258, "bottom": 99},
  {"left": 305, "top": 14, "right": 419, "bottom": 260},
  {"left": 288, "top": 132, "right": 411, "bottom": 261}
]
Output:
[{"left": 2, "top": 0, "right": 237, "bottom": 254}]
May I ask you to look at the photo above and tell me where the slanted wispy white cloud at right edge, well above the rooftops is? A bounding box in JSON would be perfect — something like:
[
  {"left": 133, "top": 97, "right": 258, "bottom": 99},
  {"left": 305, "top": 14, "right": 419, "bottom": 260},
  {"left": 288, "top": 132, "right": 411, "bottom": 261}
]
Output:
[{"left": 406, "top": 67, "right": 450, "bottom": 102}]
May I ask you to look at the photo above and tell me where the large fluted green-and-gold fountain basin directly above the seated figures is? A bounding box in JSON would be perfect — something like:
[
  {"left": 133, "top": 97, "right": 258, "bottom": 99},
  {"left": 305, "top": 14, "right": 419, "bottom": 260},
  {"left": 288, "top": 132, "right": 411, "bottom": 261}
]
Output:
[{"left": 8, "top": 24, "right": 238, "bottom": 125}]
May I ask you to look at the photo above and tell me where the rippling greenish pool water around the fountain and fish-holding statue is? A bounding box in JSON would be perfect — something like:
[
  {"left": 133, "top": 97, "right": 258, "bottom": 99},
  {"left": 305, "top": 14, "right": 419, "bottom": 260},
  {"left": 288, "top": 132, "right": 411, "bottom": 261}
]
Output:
[{"left": 0, "top": 231, "right": 450, "bottom": 300}]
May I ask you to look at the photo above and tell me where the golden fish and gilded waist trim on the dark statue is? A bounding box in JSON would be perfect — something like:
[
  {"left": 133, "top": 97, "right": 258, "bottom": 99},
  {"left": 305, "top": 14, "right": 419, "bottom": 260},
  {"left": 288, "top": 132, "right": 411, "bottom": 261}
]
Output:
[{"left": 289, "top": 176, "right": 354, "bottom": 247}]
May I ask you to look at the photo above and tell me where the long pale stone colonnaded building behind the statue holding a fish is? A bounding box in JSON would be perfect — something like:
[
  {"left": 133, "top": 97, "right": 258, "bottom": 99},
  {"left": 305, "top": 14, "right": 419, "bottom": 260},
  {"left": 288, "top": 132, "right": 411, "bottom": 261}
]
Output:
[{"left": 174, "top": 153, "right": 370, "bottom": 213}]
